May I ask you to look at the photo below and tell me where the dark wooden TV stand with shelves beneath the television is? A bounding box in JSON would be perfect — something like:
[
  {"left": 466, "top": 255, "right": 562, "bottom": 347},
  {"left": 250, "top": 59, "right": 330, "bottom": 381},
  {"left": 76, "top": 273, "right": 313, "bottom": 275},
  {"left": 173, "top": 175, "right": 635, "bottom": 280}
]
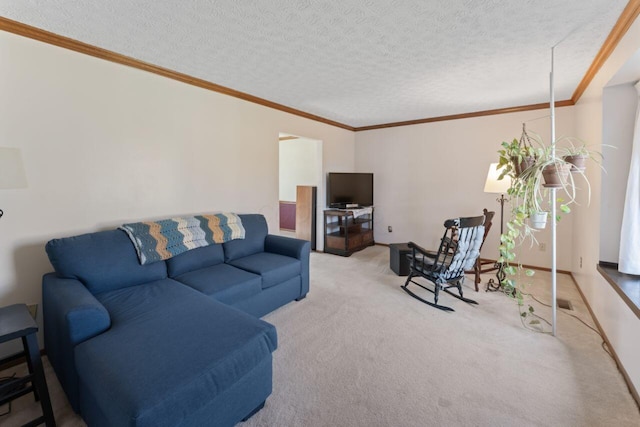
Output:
[{"left": 324, "top": 209, "right": 375, "bottom": 256}]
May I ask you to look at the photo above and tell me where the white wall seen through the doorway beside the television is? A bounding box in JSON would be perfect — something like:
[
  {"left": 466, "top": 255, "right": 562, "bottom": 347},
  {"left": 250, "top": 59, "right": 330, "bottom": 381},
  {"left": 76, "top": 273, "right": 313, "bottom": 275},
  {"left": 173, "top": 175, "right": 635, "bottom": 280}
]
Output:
[{"left": 279, "top": 138, "right": 322, "bottom": 202}]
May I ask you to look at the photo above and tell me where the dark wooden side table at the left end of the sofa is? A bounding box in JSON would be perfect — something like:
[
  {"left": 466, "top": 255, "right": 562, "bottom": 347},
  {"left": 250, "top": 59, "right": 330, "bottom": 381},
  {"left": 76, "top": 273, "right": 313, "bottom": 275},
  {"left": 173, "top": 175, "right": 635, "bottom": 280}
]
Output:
[{"left": 0, "top": 304, "right": 56, "bottom": 427}]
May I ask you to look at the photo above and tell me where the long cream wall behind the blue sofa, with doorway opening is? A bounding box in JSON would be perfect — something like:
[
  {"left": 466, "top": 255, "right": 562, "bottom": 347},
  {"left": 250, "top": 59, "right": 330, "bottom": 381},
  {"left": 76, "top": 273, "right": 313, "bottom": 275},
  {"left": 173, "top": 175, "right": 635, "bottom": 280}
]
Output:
[{"left": 0, "top": 32, "right": 354, "bottom": 352}]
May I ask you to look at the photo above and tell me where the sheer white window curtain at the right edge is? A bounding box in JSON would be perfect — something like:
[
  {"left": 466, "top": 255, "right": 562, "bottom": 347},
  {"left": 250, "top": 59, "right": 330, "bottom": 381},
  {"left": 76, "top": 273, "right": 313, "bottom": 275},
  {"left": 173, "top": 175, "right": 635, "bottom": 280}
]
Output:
[{"left": 618, "top": 82, "right": 640, "bottom": 275}]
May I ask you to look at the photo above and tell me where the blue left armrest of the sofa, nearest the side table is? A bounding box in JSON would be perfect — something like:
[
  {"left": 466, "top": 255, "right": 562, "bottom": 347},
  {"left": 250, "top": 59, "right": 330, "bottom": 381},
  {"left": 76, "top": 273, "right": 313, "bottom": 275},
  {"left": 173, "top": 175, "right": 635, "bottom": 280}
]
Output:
[{"left": 42, "top": 273, "right": 111, "bottom": 411}]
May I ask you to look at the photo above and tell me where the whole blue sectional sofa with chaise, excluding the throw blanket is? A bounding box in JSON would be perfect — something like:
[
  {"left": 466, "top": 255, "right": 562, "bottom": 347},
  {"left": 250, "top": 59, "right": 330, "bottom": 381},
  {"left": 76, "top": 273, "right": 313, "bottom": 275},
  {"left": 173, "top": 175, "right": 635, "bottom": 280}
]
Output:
[{"left": 42, "top": 214, "right": 310, "bottom": 427}]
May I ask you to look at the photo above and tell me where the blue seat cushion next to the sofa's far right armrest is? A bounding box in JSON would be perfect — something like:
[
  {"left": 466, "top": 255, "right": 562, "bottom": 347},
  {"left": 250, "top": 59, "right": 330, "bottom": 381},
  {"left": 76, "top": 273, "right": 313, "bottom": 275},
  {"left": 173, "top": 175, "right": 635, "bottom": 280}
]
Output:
[{"left": 229, "top": 252, "right": 301, "bottom": 289}]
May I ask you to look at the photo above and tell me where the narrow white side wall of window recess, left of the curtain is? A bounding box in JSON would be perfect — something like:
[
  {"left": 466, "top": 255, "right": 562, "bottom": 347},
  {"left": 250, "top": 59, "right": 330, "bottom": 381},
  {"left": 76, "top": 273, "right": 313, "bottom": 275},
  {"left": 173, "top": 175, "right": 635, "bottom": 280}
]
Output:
[{"left": 600, "top": 84, "right": 638, "bottom": 264}]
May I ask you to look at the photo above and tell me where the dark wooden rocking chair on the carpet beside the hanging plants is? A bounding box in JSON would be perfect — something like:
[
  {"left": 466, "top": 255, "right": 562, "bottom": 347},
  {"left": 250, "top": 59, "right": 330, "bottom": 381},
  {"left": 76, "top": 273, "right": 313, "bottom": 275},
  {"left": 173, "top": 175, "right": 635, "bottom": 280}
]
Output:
[{"left": 402, "top": 216, "right": 485, "bottom": 311}]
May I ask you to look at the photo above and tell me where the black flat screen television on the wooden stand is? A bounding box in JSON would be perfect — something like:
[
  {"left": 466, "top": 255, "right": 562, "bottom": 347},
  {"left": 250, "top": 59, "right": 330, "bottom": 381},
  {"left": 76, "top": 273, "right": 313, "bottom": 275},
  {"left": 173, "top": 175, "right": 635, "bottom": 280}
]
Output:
[{"left": 327, "top": 172, "right": 373, "bottom": 209}]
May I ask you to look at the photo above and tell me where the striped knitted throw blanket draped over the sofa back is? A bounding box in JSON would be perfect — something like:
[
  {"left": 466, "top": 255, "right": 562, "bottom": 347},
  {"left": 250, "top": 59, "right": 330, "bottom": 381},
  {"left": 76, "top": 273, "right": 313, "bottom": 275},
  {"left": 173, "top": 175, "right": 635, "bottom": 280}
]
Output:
[{"left": 119, "top": 213, "right": 245, "bottom": 265}]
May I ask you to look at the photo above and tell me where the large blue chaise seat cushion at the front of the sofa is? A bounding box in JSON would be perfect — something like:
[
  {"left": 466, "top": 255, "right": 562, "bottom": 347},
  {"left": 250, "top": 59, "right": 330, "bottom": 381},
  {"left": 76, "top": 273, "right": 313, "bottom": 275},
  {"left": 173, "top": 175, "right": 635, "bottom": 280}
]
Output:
[{"left": 75, "top": 279, "right": 277, "bottom": 426}]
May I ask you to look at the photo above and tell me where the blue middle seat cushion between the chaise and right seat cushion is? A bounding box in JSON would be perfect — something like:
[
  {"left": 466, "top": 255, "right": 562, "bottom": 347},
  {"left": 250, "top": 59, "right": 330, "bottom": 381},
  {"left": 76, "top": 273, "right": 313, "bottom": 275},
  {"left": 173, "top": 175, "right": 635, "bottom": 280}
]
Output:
[{"left": 175, "top": 264, "right": 262, "bottom": 305}]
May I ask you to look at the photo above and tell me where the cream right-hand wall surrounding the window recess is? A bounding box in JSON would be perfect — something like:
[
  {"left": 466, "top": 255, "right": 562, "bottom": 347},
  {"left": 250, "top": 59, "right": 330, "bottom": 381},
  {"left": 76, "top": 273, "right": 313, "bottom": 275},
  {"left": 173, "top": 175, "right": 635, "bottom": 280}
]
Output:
[{"left": 572, "top": 15, "right": 640, "bottom": 398}]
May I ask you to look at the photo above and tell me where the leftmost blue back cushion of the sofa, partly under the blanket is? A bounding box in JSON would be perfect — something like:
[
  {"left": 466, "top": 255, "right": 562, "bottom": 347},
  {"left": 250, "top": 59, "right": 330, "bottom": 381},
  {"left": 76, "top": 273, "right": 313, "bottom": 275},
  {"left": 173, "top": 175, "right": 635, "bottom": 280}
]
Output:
[{"left": 45, "top": 230, "right": 167, "bottom": 294}]
